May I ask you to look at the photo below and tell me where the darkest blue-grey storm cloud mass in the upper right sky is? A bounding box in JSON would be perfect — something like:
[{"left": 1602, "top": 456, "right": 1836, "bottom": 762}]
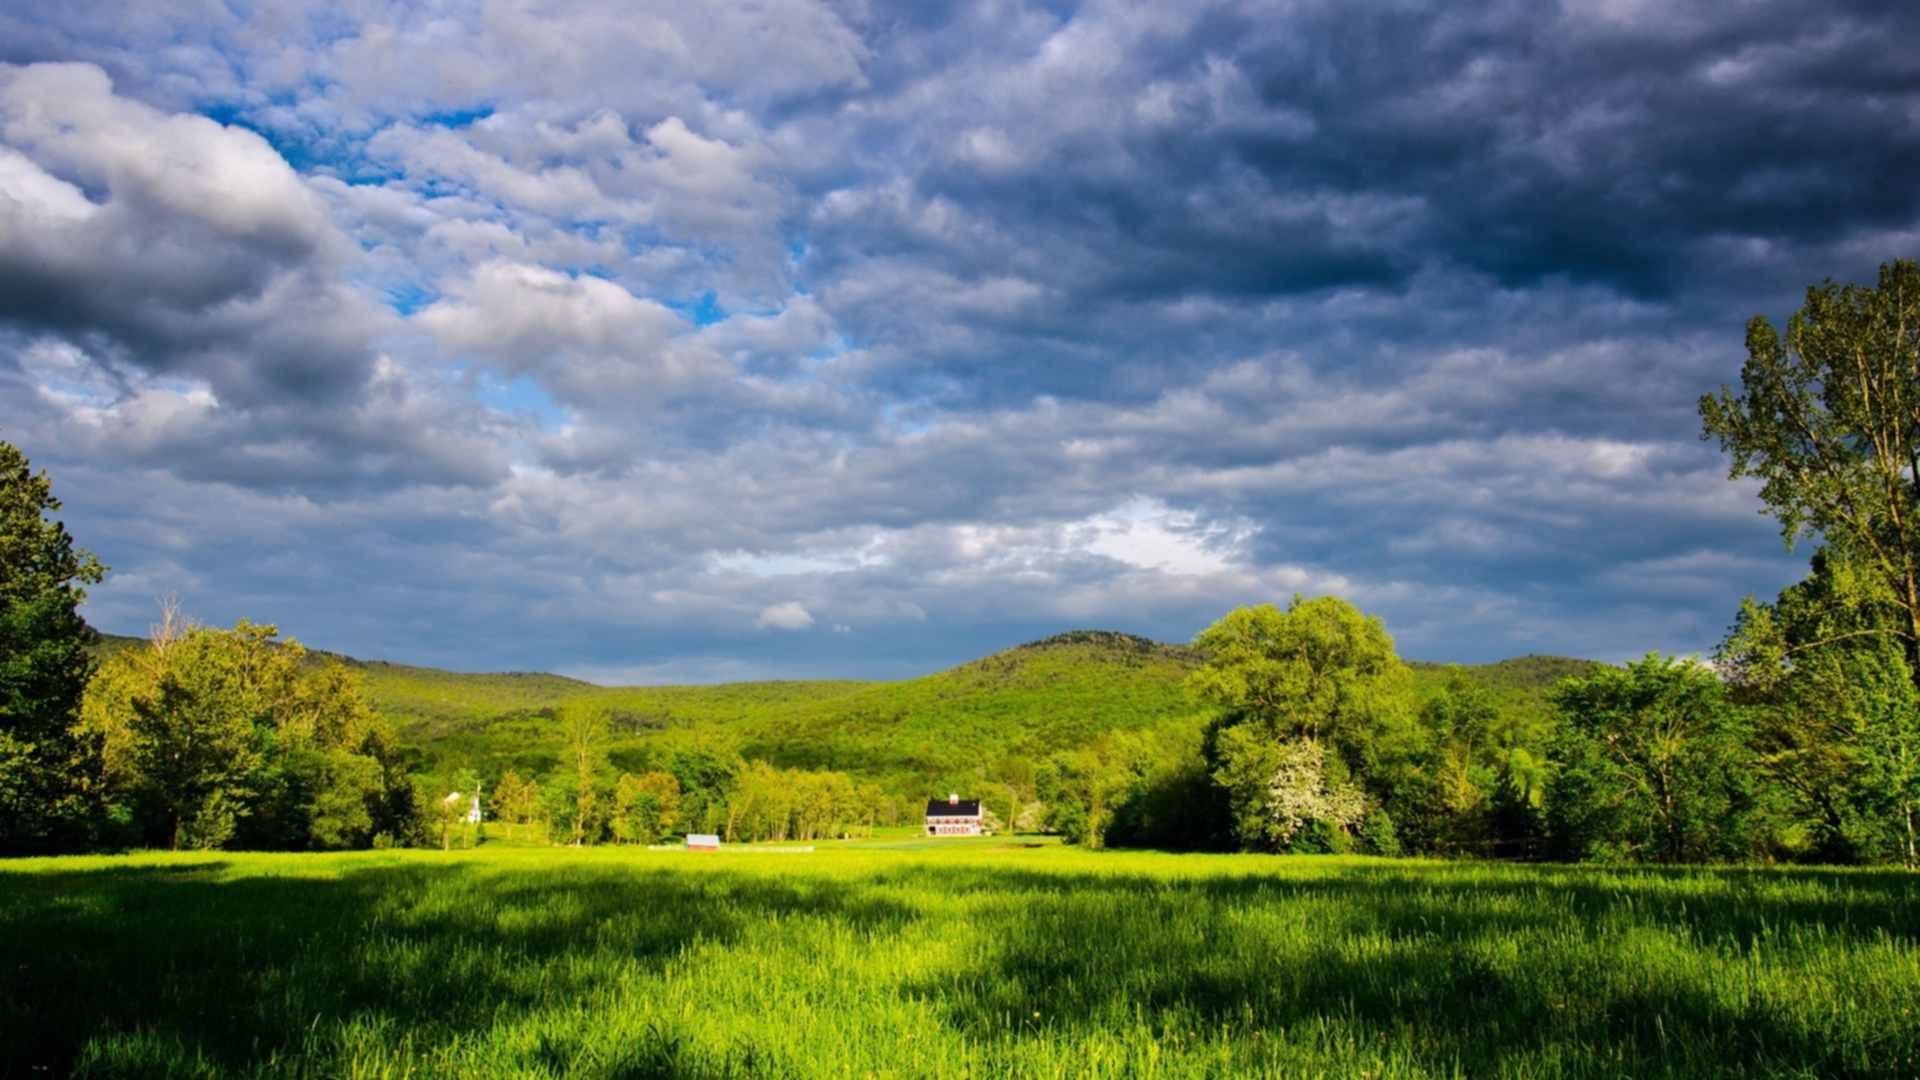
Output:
[{"left": 810, "top": 4, "right": 1920, "bottom": 345}]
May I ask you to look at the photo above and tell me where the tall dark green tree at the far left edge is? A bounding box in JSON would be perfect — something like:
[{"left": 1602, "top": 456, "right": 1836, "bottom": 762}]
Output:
[{"left": 0, "top": 442, "right": 106, "bottom": 851}]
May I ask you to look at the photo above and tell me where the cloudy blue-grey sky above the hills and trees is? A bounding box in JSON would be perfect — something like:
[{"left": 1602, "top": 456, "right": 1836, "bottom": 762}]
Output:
[{"left": 0, "top": 0, "right": 1920, "bottom": 682}]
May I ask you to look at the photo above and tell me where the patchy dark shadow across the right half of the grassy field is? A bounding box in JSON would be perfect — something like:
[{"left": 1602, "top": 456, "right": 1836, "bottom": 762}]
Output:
[{"left": 902, "top": 865, "right": 1920, "bottom": 1076}]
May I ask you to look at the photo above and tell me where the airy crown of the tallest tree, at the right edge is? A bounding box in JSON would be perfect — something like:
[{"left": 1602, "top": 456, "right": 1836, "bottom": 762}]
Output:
[{"left": 1699, "top": 259, "right": 1920, "bottom": 686}]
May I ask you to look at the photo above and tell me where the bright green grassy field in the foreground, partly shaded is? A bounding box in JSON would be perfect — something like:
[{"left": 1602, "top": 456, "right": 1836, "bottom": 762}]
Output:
[{"left": 0, "top": 838, "right": 1920, "bottom": 1076}]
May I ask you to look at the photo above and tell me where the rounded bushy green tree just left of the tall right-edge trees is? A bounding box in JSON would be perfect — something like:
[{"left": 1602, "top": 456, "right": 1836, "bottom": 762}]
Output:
[{"left": 1549, "top": 653, "right": 1755, "bottom": 863}]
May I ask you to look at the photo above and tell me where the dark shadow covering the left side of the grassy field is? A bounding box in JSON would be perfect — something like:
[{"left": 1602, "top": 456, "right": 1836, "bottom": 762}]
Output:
[{"left": 0, "top": 863, "right": 916, "bottom": 1076}]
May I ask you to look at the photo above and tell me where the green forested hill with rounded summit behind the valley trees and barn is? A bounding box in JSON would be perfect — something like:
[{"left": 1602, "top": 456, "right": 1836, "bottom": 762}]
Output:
[{"left": 86, "top": 630, "right": 1590, "bottom": 790}]
